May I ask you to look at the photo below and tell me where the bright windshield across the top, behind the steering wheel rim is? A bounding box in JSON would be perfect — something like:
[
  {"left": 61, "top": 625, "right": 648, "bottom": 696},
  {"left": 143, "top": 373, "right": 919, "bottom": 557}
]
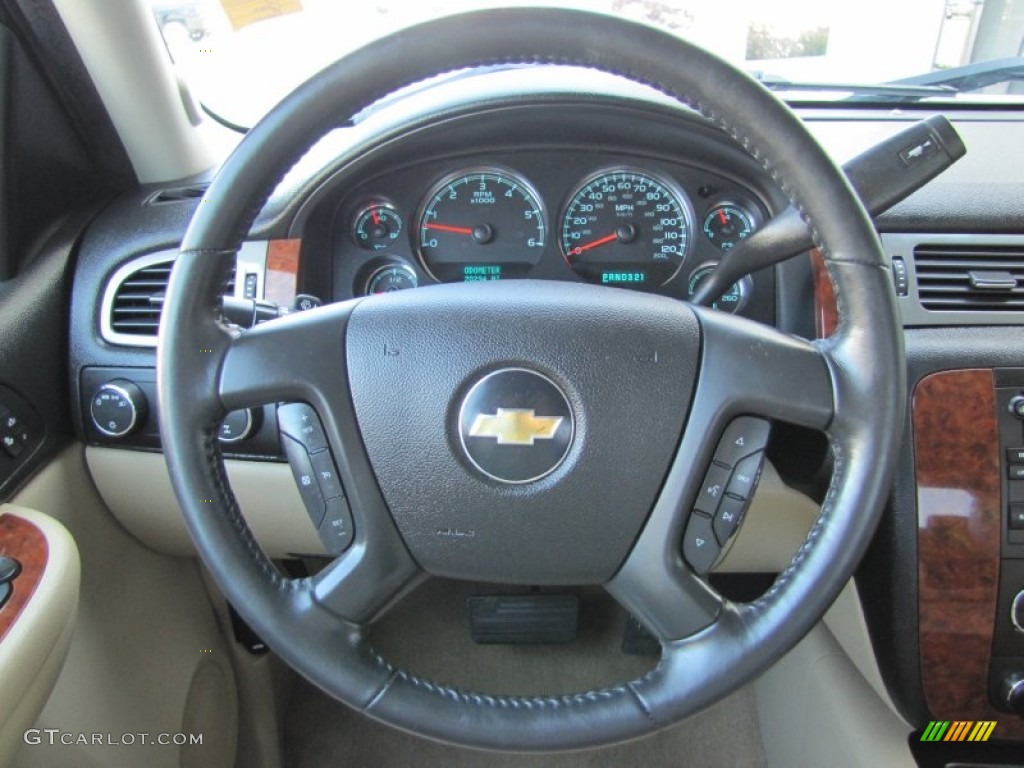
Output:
[{"left": 148, "top": 0, "right": 1024, "bottom": 129}]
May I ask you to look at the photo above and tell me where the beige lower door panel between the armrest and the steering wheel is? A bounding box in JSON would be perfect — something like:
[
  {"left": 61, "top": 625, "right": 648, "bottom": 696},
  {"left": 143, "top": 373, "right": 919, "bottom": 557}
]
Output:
[{"left": 13, "top": 445, "right": 237, "bottom": 768}]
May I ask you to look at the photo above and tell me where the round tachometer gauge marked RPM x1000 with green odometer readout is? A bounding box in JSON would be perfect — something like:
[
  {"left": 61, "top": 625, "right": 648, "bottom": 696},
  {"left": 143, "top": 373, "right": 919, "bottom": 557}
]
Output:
[{"left": 417, "top": 168, "right": 547, "bottom": 283}]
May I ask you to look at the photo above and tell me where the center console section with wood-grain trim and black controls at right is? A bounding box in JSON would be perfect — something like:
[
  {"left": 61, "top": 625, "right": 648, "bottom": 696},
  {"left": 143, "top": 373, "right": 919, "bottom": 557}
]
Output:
[{"left": 912, "top": 369, "right": 1024, "bottom": 738}]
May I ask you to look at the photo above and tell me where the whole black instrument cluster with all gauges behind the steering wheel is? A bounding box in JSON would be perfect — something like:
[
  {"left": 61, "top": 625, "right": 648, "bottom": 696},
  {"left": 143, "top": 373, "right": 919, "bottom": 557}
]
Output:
[{"left": 333, "top": 151, "right": 767, "bottom": 312}]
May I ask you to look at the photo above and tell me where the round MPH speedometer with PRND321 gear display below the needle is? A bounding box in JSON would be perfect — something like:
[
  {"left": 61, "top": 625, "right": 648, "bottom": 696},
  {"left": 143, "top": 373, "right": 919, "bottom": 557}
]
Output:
[{"left": 561, "top": 168, "right": 692, "bottom": 288}]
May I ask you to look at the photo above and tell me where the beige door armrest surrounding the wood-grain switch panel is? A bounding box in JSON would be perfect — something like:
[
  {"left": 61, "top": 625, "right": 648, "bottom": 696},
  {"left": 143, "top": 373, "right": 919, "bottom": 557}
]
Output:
[{"left": 0, "top": 504, "right": 80, "bottom": 766}]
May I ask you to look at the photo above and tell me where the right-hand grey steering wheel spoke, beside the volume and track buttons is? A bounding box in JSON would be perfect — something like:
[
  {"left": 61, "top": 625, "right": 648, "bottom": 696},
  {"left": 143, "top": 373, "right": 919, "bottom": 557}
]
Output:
[{"left": 607, "top": 310, "right": 834, "bottom": 642}]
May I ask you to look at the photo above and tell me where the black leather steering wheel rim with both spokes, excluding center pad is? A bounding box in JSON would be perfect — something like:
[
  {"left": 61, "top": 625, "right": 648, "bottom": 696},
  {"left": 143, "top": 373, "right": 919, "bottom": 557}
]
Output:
[{"left": 158, "top": 9, "right": 904, "bottom": 751}]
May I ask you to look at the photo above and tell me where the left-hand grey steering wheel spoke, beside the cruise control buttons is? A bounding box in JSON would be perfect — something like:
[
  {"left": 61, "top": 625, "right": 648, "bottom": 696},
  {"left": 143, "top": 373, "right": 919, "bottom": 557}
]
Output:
[{"left": 218, "top": 296, "right": 422, "bottom": 624}]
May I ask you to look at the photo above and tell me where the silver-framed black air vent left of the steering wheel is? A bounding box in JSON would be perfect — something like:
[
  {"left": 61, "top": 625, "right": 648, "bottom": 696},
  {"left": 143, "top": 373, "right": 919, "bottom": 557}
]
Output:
[{"left": 103, "top": 251, "right": 236, "bottom": 345}]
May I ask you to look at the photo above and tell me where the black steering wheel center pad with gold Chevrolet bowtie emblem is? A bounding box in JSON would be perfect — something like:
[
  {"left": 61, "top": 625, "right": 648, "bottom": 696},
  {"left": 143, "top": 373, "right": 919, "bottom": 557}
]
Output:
[{"left": 345, "top": 281, "right": 700, "bottom": 584}]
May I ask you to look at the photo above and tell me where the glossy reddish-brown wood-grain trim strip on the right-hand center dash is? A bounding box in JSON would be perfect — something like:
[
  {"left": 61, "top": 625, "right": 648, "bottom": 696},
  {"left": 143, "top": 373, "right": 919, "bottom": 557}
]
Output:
[{"left": 912, "top": 370, "right": 1024, "bottom": 738}]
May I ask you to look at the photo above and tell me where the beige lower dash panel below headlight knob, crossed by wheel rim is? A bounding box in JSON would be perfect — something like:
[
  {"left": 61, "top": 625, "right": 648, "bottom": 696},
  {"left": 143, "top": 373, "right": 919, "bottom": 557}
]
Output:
[{"left": 86, "top": 445, "right": 325, "bottom": 557}]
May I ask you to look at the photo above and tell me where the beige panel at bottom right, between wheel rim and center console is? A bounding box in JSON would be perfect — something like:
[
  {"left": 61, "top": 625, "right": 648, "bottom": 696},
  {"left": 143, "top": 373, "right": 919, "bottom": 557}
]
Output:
[{"left": 755, "top": 623, "right": 916, "bottom": 768}]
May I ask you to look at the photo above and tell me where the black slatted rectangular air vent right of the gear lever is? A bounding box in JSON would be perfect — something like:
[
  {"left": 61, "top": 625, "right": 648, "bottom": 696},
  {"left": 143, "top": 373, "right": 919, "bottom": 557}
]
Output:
[{"left": 913, "top": 244, "right": 1024, "bottom": 312}]
